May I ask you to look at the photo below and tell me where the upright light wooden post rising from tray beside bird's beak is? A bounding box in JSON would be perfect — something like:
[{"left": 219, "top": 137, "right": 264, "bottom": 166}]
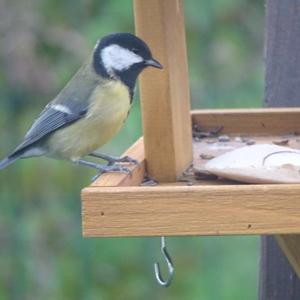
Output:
[{"left": 134, "top": 0, "right": 192, "bottom": 182}]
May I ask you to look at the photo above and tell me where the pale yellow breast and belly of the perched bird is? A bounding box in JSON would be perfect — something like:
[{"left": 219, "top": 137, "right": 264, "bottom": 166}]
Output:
[{"left": 49, "top": 81, "right": 130, "bottom": 160}]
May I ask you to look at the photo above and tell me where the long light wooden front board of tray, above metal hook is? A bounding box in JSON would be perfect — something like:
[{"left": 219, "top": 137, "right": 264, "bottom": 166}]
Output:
[{"left": 82, "top": 184, "right": 300, "bottom": 236}]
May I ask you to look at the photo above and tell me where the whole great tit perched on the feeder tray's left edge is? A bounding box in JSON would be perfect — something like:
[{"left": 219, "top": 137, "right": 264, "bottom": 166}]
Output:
[{"left": 0, "top": 33, "right": 162, "bottom": 174}]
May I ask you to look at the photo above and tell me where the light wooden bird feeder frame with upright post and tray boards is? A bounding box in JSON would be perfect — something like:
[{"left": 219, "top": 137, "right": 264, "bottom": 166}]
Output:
[{"left": 82, "top": 0, "right": 300, "bottom": 286}]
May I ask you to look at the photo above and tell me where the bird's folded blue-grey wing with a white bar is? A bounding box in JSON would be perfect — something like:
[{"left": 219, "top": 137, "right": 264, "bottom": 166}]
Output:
[{"left": 11, "top": 101, "right": 87, "bottom": 156}]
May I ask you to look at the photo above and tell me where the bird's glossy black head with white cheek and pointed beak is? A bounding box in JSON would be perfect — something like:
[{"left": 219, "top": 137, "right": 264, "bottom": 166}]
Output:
[{"left": 93, "top": 33, "right": 162, "bottom": 90}]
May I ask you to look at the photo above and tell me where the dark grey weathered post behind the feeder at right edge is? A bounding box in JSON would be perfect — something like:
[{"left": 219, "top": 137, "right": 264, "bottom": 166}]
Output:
[{"left": 259, "top": 0, "right": 300, "bottom": 300}]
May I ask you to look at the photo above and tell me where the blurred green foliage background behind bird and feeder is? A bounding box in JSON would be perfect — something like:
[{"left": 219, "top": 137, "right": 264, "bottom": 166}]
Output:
[{"left": 0, "top": 0, "right": 264, "bottom": 300}]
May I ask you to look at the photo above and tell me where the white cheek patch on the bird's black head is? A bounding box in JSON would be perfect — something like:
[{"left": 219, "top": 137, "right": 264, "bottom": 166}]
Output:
[{"left": 100, "top": 44, "right": 143, "bottom": 75}]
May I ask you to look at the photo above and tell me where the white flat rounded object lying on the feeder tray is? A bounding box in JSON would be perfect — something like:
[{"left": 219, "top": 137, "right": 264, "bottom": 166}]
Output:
[{"left": 205, "top": 144, "right": 300, "bottom": 183}]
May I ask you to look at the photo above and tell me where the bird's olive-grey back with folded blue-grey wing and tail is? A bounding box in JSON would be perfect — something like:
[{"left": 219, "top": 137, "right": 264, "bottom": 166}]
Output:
[{"left": 0, "top": 62, "right": 99, "bottom": 169}]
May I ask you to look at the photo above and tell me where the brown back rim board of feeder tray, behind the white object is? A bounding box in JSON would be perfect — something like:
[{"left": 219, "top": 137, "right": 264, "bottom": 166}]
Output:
[{"left": 192, "top": 108, "right": 300, "bottom": 135}]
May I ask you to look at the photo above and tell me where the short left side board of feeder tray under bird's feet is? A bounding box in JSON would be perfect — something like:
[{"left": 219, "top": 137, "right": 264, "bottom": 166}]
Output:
[{"left": 91, "top": 138, "right": 145, "bottom": 187}]
